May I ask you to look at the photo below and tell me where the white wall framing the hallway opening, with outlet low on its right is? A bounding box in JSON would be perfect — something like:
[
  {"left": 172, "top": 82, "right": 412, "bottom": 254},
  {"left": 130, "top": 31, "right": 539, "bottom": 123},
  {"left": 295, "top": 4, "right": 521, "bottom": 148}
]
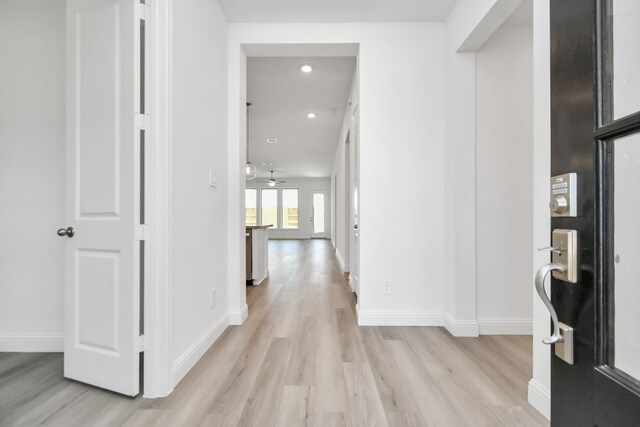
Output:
[{"left": 229, "top": 23, "right": 445, "bottom": 325}]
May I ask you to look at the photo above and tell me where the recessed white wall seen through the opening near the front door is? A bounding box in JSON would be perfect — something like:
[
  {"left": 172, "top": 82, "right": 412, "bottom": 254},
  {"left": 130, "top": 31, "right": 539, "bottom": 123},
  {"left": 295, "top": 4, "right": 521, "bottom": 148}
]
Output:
[{"left": 476, "top": 26, "right": 533, "bottom": 334}]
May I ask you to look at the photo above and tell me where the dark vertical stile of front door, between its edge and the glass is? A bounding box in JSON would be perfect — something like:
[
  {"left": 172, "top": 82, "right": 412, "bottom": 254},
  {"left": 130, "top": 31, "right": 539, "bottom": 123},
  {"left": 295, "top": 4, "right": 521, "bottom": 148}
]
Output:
[{"left": 551, "top": 0, "right": 595, "bottom": 426}]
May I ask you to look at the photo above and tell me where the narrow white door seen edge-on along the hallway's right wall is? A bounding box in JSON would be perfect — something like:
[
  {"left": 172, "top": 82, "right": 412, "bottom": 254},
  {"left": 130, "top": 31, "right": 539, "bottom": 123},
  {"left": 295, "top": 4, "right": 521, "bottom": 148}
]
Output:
[{"left": 349, "top": 110, "right": 360, "bottom": 295}]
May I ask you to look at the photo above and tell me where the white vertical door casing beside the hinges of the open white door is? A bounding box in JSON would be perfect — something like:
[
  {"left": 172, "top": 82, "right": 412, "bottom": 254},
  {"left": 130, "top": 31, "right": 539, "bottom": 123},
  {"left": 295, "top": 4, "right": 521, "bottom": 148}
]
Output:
[{"left": 143, "top": 0, "right": 173, "bottom": 398}]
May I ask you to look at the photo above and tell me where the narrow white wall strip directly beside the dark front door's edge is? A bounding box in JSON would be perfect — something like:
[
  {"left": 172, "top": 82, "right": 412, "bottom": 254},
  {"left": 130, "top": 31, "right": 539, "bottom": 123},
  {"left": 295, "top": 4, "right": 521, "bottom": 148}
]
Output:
[{"left": 529, "top": 1, "right": 551, "bottom": 418}]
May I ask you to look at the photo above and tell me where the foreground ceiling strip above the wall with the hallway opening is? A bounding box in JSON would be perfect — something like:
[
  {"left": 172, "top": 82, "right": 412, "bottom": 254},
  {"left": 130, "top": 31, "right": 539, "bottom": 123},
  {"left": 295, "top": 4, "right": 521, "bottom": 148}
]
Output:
[{"left": 218, "top": 0, "right": 456, "bottom": 23}]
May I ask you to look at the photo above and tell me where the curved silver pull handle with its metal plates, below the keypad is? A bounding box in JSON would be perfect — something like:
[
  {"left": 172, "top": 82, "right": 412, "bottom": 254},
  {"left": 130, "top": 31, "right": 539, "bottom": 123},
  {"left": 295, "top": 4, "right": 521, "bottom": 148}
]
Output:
[{"left": 535, "top": 229, "right": 580, "bottom": 365}]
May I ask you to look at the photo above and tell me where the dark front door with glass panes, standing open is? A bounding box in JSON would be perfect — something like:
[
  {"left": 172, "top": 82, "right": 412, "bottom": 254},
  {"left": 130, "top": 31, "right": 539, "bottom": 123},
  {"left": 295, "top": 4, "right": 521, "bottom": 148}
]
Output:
[{"left": 550, "top": 0, "right": 640, "bottom": 427}]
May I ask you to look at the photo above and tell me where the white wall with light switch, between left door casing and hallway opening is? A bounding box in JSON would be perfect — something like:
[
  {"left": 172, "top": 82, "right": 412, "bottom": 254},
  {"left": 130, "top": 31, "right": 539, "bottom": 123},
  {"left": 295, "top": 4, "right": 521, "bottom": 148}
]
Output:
[{"left": 171, "top": 0, "right": 228, "bottom": 383}]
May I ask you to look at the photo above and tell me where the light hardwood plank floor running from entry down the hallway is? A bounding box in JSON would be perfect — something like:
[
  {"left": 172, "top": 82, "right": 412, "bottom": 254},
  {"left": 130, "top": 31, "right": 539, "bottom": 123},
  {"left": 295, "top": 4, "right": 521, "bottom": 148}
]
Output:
[{"left": 0, "top": 240, "right": 548, "bottom": 427}]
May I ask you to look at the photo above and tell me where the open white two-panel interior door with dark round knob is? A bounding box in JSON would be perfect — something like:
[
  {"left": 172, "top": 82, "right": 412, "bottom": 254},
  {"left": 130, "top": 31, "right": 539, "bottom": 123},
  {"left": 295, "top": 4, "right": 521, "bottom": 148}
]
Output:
[{"left": 58, "top": 0, "right": 140, "bottom": 396}]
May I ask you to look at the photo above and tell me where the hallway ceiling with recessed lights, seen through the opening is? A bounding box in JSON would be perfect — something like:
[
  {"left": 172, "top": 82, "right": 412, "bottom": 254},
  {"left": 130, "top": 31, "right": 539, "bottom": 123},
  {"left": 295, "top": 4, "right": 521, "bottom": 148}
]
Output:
[{"left": 247, "top": 57, "right": 356, "bottom": 178}]
